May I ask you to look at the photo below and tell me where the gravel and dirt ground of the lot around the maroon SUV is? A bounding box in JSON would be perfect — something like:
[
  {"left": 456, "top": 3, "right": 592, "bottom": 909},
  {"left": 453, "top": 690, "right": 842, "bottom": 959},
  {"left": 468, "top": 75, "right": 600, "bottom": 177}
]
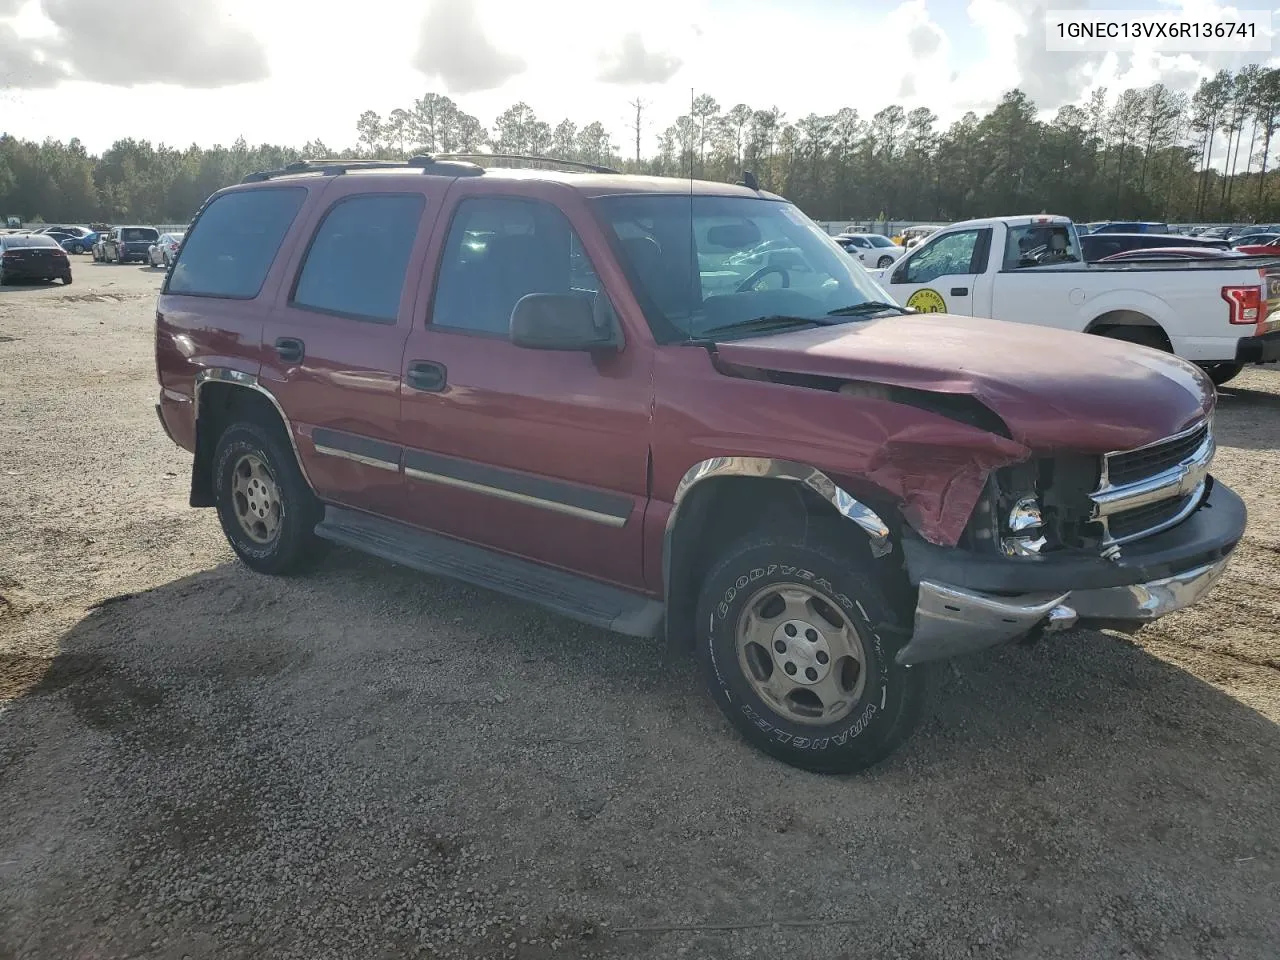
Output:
[{"left": 0, "top": 257, "right": 1280, "bottom": 960}]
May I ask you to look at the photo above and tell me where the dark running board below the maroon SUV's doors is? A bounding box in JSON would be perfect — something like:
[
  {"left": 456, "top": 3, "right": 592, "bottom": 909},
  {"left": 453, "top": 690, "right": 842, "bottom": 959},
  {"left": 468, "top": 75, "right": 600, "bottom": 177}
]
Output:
[{"left": 316, "top": 507, "right": 663, "bottom": 636}]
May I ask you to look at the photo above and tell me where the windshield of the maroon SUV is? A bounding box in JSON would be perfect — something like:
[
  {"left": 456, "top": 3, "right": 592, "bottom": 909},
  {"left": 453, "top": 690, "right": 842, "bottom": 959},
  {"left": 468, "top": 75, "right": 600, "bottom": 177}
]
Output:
[{"left": 594, "top": 195, "right": 892, "bottom": 343}]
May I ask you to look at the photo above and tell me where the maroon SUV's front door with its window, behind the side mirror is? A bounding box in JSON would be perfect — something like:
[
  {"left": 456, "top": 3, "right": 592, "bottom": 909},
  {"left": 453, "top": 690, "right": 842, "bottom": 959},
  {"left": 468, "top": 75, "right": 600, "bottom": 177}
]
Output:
[{"left": 401, "top": 185, "right": 653, "bottom": 588}]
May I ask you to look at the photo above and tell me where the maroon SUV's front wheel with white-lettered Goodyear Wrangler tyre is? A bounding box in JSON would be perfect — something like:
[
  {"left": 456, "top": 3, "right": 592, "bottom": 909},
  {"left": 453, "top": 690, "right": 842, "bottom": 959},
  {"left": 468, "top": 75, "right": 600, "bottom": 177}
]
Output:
[{"left": 698, "top": 536, "right": 928, "bottom": 773}]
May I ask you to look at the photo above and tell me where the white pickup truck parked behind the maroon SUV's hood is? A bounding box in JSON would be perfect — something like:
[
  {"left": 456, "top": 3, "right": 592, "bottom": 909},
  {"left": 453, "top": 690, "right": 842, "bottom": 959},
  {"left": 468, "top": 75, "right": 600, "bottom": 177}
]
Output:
[{"left": 872, "top": 216, "right": 1280, "bottom": 384}]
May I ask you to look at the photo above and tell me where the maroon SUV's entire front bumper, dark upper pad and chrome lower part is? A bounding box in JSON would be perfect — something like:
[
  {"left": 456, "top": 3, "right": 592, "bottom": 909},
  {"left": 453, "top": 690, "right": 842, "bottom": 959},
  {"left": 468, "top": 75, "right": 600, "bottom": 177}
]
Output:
[{"left": 897, "top": 484, "right": 1248, "bottom": 664}]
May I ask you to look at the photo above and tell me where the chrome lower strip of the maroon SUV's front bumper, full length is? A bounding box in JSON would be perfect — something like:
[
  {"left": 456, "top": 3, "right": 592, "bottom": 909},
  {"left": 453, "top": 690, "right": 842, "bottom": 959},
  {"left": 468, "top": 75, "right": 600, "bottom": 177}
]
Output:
[{"left": 897, "top": 557, "right": 1229, "bottom": 664}]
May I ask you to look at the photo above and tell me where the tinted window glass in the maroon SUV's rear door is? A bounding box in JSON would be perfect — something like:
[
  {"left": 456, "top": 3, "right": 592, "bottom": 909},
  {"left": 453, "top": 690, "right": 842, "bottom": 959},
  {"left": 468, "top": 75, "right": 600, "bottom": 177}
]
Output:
[{"left": 293, "top": 193, "right": 426, "bottom": 324}]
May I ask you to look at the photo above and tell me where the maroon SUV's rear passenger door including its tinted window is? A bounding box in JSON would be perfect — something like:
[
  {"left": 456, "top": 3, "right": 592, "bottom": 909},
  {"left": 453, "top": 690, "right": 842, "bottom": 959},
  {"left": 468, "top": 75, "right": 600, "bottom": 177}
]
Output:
[{"left": 261, "top": 180, "right": 448, "bottom": 527}]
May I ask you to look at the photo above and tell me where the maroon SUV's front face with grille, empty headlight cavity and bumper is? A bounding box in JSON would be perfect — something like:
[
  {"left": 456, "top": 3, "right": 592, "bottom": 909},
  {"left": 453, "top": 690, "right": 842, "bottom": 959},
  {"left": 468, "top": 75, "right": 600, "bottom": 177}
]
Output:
[{"left": 899, "top": 420, "right": 1245, "bottom": 663}]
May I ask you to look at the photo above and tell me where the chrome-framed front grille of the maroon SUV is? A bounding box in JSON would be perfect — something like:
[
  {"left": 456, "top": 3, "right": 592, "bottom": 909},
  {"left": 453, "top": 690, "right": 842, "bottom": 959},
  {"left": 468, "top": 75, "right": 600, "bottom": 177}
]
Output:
[{"left": 1091, "top": 421, "right": 1213, "bottom": 547}]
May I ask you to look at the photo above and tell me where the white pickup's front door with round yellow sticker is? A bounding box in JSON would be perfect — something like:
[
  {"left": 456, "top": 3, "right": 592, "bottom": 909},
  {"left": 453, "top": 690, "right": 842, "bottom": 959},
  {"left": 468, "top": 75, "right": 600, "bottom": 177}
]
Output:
[{"left": 886, "top": 229, "right": 991, "bottom": 316}]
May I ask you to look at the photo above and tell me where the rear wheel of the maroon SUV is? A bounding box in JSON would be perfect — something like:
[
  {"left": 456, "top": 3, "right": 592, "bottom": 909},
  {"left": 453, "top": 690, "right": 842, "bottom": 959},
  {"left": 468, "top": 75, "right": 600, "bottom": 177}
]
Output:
[{"left": 214, "top": 422, "right": 320, "bottom": 573}]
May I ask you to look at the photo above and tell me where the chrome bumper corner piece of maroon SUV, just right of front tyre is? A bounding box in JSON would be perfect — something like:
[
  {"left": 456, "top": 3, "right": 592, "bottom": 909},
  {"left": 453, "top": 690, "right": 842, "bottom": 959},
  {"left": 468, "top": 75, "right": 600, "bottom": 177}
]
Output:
[{"left": 896, "top": 580, "right": 1076, "bottom": 666}]
